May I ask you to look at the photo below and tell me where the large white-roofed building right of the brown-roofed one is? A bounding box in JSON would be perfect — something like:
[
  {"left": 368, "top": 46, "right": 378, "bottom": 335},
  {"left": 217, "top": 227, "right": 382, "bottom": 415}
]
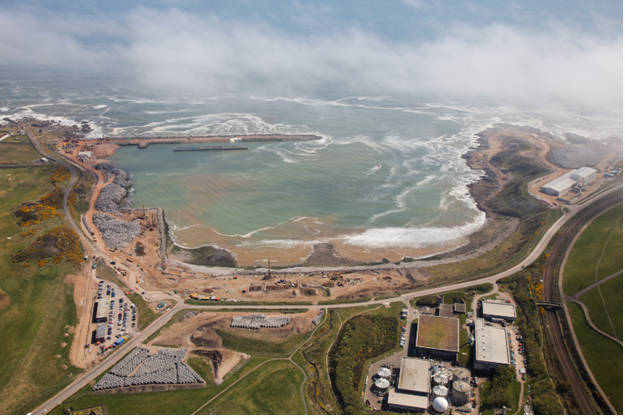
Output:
[{"left": 474, "top": 318, "right": 510, "bottom": 370}]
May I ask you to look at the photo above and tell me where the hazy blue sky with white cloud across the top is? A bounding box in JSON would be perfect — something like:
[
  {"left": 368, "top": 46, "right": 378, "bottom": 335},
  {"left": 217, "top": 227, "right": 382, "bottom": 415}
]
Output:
[{"left": 0, "top": 0, "right": 623, "bottom": 110}]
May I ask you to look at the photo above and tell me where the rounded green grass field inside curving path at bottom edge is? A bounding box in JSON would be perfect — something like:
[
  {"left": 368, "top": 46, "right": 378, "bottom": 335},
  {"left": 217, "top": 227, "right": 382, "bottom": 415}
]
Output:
[{"left": 200, "top": 360, "right": 304, "bottom": 415}]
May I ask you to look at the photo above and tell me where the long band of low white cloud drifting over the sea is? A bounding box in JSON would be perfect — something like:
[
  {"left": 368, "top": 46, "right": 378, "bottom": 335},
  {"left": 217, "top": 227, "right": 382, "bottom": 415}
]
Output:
[{"left": 0, "top": 6, "right": 623, "bottom": 109}]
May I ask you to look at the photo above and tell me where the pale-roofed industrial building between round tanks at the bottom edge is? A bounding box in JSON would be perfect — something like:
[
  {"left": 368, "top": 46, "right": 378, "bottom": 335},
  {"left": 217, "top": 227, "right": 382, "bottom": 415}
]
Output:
[{"left": 387, "top": 357, "right": 431, "bottom": 413}]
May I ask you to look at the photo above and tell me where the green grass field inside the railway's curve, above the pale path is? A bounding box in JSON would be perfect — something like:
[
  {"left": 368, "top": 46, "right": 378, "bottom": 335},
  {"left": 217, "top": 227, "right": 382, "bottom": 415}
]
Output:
[{"left": 563, "top": 205, "right": 623, "bottom": 295}]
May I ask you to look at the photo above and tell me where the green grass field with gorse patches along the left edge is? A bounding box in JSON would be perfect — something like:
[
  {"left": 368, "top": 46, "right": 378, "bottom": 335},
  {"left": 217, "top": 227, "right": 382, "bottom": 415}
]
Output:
[{"left": 0, "top": 164, "right": 80, "bottom": 414}]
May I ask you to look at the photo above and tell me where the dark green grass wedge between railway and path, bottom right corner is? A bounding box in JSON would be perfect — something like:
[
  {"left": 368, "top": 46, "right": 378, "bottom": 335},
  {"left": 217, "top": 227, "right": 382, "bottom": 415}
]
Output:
[{"left": 567, "top": 302, "right": 623, "bottom": 414}]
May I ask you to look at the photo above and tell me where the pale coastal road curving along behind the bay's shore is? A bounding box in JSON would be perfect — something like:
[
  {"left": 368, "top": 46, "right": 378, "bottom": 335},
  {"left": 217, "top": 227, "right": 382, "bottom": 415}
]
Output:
[{"left": 33, "top": 184, "right": 623, "bottom": 414}]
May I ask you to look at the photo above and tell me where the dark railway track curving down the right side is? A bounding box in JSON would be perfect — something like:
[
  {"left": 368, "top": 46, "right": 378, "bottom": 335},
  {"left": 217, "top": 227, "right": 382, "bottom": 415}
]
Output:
[{"left": 543, "top": 193, "right": 623, "bottom": 415}]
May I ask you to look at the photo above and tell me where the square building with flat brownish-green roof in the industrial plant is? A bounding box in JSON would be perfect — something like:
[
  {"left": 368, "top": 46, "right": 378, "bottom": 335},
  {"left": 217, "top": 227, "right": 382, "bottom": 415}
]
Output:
[{"left": 415, "top": 315, "right": 460, "bottom": 361}]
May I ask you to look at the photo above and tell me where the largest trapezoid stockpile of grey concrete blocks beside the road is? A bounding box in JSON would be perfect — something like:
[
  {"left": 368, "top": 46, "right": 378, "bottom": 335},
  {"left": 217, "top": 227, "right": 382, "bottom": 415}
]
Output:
[{"left": 93, "top": 347, "right": 205, "bottom": 391}]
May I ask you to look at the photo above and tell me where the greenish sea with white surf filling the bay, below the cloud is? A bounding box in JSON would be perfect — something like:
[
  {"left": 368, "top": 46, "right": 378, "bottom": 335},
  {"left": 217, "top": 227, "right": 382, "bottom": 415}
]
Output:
[{"left": 0, "top": 2, "right": 622, "bottom": 265}]
